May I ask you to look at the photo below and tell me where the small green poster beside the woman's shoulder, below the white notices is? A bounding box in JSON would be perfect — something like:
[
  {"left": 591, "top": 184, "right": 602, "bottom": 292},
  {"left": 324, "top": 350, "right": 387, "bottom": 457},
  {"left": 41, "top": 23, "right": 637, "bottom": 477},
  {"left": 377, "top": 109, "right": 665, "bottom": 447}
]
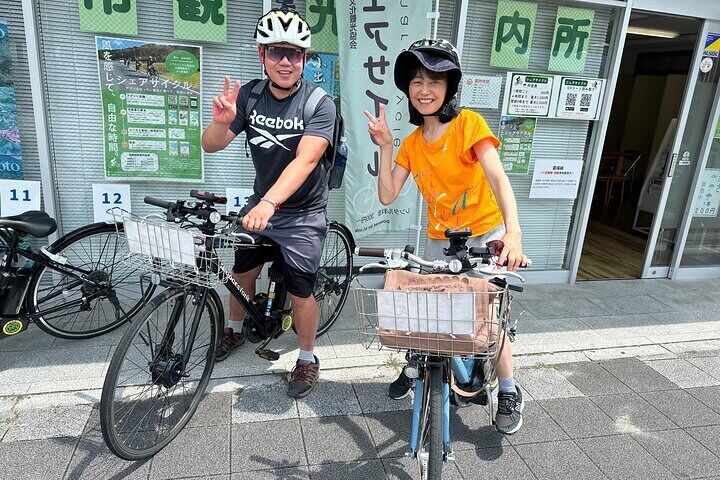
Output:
[{"left": 498, "top": 117, "right": 537, "bottom": 175}]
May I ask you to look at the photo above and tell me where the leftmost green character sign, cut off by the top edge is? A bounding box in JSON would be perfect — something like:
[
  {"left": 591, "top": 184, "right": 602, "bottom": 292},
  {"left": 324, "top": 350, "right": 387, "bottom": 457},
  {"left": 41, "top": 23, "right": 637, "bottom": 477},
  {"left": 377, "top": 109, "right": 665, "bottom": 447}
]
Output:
[{"left": 78, "top": 0, "right": 137, "bottom": 35}]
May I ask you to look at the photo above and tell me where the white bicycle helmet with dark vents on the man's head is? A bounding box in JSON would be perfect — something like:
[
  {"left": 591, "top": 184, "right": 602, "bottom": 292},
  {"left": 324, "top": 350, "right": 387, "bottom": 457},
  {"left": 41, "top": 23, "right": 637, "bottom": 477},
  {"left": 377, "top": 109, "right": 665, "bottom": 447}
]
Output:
[{"left": 255, "top": 3, "right": 311, "bottom": 50}]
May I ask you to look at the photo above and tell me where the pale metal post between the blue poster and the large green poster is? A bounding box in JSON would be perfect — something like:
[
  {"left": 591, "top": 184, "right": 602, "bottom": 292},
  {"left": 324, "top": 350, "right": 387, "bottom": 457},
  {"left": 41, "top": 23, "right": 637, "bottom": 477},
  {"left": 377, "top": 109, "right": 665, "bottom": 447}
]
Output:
[{"left": 22, "top": 0, "right": 62, "bottom": 243}]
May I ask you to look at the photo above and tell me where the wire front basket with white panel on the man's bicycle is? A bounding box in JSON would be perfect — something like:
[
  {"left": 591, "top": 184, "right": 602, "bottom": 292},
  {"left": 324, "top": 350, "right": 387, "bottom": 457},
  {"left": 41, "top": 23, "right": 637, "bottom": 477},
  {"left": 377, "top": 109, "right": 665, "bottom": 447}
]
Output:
[{"left": 110, "top": 208, "right": 243, "bottom": 288}]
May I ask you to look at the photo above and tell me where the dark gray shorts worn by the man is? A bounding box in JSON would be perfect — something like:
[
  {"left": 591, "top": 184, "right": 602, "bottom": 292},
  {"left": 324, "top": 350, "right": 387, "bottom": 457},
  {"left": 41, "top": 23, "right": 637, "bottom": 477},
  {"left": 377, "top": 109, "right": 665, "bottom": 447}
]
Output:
[{"left": 233, "top": 211, "right": 329, "bottom": 298}]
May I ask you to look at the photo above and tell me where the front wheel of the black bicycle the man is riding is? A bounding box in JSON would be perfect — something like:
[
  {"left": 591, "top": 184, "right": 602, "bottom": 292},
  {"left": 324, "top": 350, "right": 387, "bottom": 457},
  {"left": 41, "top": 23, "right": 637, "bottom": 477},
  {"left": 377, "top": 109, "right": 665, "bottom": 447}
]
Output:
[{"left": 100, "top": 287, "right": 224, "bottom": 460}]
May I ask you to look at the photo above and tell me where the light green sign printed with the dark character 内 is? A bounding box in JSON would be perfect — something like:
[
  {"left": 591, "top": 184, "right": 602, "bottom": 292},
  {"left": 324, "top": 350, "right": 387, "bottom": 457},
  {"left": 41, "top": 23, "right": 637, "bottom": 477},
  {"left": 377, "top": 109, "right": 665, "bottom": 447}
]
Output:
[{"left": 490, "top": 0, "right": 537, "bottom": 69}]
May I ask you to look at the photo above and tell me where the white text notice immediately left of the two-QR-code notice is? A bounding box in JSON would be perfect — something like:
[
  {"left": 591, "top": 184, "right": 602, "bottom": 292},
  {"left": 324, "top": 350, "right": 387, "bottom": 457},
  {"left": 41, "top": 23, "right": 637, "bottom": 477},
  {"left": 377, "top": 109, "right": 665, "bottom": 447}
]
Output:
[{"left": 502, "top": 72, "right": 555, "bottom": 117}]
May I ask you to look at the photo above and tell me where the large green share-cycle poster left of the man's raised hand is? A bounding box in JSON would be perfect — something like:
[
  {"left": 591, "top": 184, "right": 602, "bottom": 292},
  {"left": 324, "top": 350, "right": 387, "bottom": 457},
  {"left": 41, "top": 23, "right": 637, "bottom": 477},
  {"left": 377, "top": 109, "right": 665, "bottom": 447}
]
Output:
[{"left": 95, "top": 37, "right": 203, "bottom": 181}]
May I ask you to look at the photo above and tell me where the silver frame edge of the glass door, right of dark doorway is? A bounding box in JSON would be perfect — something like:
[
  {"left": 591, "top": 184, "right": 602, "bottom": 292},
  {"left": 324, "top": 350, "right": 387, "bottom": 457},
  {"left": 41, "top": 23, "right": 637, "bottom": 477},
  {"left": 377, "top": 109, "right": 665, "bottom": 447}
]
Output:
[{"left": 640, "top": 20, "right": 711, "bottom": 278}]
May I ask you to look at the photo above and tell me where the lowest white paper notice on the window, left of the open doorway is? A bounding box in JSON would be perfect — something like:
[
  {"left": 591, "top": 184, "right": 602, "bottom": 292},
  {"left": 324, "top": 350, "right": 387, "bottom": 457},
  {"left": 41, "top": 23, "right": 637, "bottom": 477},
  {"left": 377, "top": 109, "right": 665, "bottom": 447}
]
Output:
[{"left": 530, "top": 160, "right": 583, "bottom": 199}]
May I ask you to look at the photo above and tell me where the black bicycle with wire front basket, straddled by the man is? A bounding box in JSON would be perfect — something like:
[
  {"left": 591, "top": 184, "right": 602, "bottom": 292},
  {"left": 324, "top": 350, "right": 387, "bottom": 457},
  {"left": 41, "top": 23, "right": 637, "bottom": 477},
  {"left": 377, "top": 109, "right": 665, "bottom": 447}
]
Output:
[{"left": 100, "top": 190, "right": 353, "bottom": 460}]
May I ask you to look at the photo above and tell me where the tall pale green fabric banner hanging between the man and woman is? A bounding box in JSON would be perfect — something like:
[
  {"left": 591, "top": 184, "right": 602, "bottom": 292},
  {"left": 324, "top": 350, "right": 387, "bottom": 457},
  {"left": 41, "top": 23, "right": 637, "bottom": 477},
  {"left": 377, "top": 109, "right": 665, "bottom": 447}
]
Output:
[{"left": 337, "top": 0, "right": 432, "bottom": 238}]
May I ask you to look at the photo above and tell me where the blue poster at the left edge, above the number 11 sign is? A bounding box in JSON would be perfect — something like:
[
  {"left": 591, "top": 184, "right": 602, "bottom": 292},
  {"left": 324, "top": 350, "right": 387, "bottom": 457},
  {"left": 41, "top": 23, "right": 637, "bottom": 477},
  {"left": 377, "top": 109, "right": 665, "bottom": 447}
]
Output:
[{"left": 0, "top": 20, "right": 23, "bottom": 180}]
